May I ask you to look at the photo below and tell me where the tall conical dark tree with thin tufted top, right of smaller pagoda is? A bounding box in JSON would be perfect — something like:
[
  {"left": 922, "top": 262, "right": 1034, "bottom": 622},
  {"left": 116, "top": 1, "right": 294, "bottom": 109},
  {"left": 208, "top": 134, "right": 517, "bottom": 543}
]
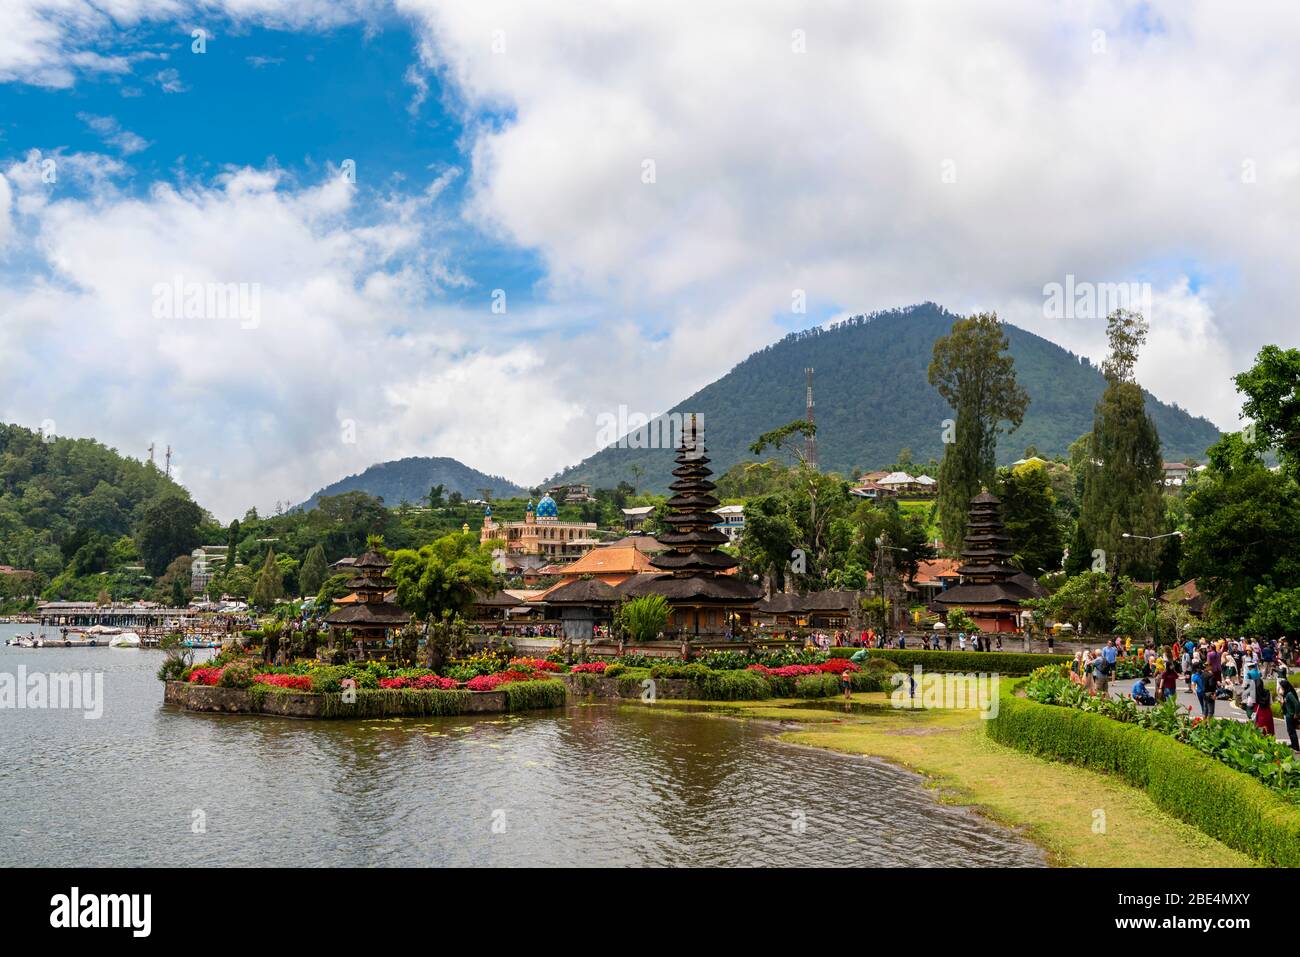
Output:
[{"left": 1079, "top": 309, "right": 1165, "bottom": 580}]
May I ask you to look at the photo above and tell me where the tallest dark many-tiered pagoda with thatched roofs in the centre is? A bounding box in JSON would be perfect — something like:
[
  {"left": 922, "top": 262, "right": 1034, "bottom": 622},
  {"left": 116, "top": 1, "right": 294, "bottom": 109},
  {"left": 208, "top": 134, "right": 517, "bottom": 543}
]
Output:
[{"left": 618, "top": 416, "right": 763, "bottom": 640}]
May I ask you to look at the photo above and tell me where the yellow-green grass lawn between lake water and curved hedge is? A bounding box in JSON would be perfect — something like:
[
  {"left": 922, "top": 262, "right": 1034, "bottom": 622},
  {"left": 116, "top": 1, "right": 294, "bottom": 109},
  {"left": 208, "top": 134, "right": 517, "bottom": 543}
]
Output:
[{"left": 634, "top": 693, "right": 1256, "bottom": 867}]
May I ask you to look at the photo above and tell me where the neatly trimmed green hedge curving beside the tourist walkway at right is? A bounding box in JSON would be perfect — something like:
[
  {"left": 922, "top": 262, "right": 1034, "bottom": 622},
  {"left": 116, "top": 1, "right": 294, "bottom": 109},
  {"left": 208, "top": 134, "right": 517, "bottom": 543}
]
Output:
[{"left": 984, "top": 693, "right": 1300, "bottom": 867}]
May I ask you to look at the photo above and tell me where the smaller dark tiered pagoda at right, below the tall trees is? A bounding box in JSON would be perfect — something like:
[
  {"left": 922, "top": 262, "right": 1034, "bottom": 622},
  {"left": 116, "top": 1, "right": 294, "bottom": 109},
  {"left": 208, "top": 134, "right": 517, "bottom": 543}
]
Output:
[{"left": 930, "top": 490, "right": 1045, "bottom": 632}]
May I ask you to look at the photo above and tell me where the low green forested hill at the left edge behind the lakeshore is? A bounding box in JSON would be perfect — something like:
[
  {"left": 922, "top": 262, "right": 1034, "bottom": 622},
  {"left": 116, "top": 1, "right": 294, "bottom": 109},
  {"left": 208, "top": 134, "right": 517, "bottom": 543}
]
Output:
[{"left": 0, "top": 424, "right": 198, "bottom": 579}]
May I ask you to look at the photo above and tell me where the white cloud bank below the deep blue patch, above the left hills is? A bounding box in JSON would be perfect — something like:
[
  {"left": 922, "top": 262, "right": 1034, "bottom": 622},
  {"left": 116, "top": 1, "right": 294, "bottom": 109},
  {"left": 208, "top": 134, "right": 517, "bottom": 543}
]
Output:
[{"left": 0, "top": 165, "right": 577, "bottom": 519}]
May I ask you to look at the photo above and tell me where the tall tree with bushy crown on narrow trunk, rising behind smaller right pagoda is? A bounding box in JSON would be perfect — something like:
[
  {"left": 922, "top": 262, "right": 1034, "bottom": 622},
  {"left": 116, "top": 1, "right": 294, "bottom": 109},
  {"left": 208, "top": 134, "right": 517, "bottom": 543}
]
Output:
[{"left": 930, "top": 313, "right": 1030, "bottom": 554}]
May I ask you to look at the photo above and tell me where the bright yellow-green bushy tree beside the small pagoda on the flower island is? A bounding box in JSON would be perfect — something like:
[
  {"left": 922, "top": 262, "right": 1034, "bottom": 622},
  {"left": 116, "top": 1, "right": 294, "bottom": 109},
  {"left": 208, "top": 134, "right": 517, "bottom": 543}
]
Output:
[{"left": 389, "top": 532, "right": 497, "bottom": 619}]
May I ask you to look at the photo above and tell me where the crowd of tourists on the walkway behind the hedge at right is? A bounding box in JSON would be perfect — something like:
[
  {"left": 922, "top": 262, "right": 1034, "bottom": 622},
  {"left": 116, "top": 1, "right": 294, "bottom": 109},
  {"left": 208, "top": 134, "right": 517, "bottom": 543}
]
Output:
[{"left": 1070, "top": 637, "right": 1300, "bottom": 752}]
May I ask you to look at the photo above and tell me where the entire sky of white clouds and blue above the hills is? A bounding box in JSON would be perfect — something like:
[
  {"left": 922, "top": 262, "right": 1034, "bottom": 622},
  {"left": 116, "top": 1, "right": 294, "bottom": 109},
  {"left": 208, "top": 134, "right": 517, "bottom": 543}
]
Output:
[{"left": 0, "top": 0, "right": 1300, "bottom": 519}]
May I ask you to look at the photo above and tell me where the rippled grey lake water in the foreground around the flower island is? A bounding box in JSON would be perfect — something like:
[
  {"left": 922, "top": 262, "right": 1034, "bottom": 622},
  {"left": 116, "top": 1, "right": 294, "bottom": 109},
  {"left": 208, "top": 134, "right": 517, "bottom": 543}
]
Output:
[{"left": 0, "top": 624, "right": 1043, "bottom": 866}]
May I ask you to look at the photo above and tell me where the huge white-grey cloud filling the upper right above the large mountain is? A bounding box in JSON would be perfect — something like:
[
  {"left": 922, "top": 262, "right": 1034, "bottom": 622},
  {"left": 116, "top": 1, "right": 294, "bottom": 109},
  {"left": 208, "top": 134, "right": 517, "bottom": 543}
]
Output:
[{"left": 399, "top": 0, "right": 1300, "bottom": 434}]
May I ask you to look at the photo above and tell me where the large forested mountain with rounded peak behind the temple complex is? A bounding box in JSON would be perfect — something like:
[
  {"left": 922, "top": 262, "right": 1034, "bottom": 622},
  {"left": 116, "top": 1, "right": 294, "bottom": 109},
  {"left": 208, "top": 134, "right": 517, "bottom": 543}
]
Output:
[{"left": 546, "top": 303, "right": 1219, "bottom": 492}]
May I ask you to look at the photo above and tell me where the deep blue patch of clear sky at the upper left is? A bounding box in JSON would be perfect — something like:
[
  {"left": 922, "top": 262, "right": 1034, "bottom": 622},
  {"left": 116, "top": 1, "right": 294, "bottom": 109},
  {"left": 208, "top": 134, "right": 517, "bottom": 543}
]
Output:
[{"left": 0, "top": 16, "right": 543, "bottom": 312}]
